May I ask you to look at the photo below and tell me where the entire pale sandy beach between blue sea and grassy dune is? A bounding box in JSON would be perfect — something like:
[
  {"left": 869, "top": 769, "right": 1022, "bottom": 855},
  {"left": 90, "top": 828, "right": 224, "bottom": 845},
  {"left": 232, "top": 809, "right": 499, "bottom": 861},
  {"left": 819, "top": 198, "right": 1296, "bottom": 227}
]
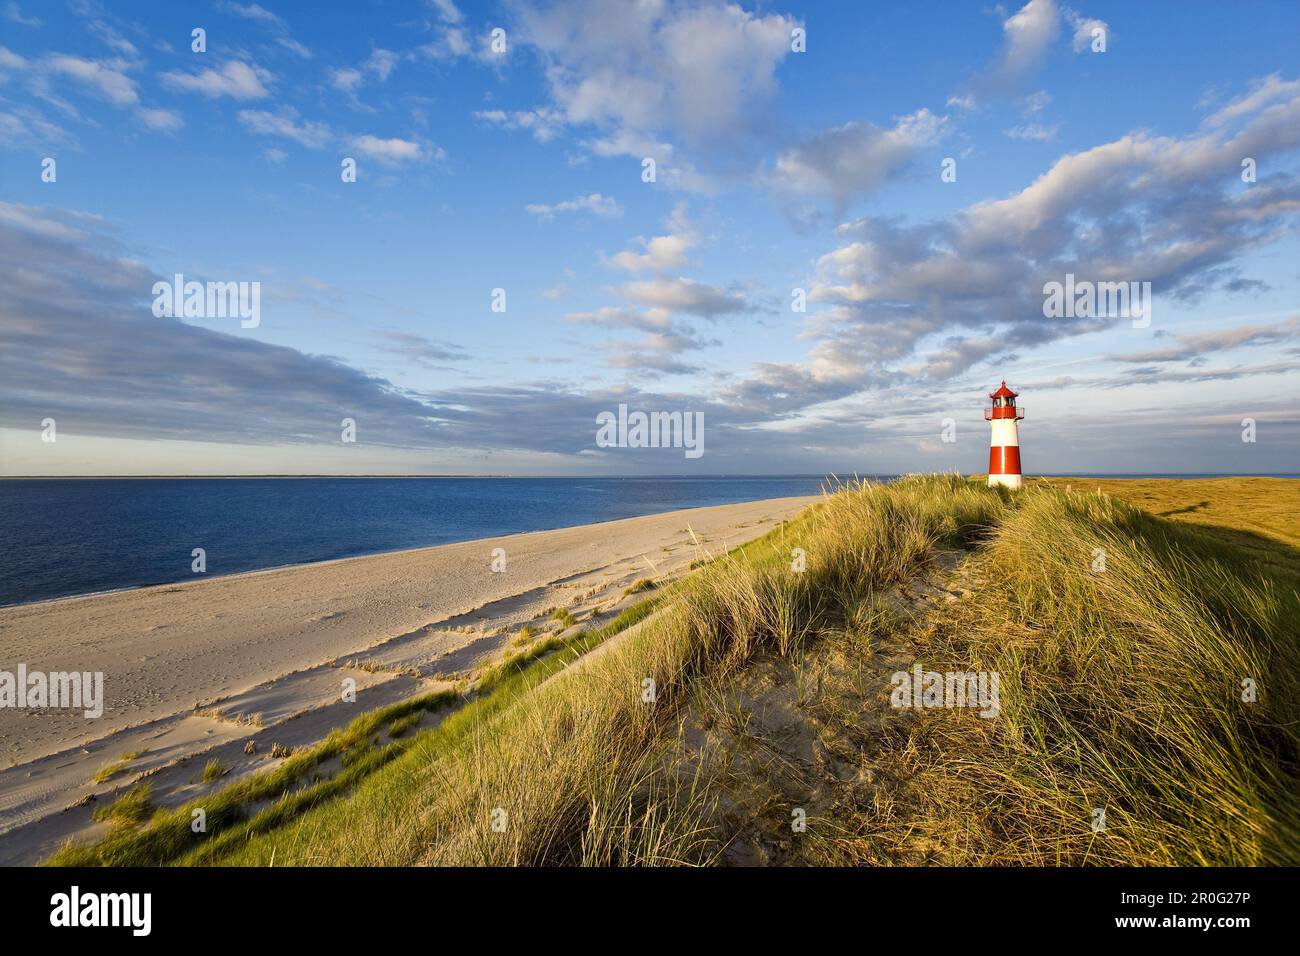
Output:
[{"left": 0, "top": 498, "right": 816, "bottom": 864}]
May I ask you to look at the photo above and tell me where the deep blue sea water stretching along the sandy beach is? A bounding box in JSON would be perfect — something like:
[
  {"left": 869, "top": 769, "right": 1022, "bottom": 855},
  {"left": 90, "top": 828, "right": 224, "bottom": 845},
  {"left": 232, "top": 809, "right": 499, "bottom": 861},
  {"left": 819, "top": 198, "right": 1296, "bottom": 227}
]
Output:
[{"left": 0, "top": 476, "right": 842, "bottom": 605}]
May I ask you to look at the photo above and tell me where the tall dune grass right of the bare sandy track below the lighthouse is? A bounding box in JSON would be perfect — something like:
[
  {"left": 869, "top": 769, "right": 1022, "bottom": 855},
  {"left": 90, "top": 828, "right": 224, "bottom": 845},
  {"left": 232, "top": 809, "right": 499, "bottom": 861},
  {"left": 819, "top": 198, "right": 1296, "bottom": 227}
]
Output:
[{"left": 806, "top": 484, "right": 1300, "bottom": 866}]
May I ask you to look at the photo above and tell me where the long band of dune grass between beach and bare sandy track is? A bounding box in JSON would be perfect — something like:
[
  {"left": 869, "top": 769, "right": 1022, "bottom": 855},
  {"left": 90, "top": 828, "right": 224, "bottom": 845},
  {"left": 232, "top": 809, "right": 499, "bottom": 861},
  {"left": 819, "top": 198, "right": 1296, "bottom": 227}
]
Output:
[{"left": 152, "top": 479, "right": 1005, "bottom": 865}]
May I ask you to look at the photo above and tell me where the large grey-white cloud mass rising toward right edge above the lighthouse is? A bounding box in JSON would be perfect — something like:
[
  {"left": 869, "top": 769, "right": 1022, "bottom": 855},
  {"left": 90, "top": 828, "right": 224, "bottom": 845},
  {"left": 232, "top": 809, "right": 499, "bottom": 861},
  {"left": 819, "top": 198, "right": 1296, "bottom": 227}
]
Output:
[{"left": 790, "top": 77, "right": 1300, "bottom": 385}]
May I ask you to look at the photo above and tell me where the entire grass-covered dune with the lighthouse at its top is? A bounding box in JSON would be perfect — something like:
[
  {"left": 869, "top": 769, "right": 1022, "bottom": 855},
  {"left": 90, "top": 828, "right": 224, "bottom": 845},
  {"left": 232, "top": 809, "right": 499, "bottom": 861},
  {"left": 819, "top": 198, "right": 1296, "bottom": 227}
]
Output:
[{"left": 51, "top": 476, "right": 1300, "bottom": 865}]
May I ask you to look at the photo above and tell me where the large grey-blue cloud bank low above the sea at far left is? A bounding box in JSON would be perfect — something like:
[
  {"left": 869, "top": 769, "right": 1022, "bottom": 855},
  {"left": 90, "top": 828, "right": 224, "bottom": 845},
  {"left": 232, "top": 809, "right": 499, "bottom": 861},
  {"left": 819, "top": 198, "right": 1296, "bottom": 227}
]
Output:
[{"left": 0, "top": 203, "right": 462, "bottom": 455}]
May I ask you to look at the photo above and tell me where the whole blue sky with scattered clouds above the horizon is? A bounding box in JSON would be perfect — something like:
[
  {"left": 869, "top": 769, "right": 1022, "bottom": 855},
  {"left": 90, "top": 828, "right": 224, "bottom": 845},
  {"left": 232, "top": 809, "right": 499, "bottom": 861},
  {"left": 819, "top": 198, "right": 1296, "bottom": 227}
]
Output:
[{"left": 0, "top": 0, "right": 1300, "bottom": 476}]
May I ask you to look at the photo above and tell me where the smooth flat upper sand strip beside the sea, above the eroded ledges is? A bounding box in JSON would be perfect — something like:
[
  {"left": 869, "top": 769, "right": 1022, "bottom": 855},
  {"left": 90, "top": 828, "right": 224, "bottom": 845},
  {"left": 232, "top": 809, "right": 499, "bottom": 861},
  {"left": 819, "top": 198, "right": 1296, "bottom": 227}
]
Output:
[{"left": 0, "top": 498, "right": 815, "bottom": 774}]
